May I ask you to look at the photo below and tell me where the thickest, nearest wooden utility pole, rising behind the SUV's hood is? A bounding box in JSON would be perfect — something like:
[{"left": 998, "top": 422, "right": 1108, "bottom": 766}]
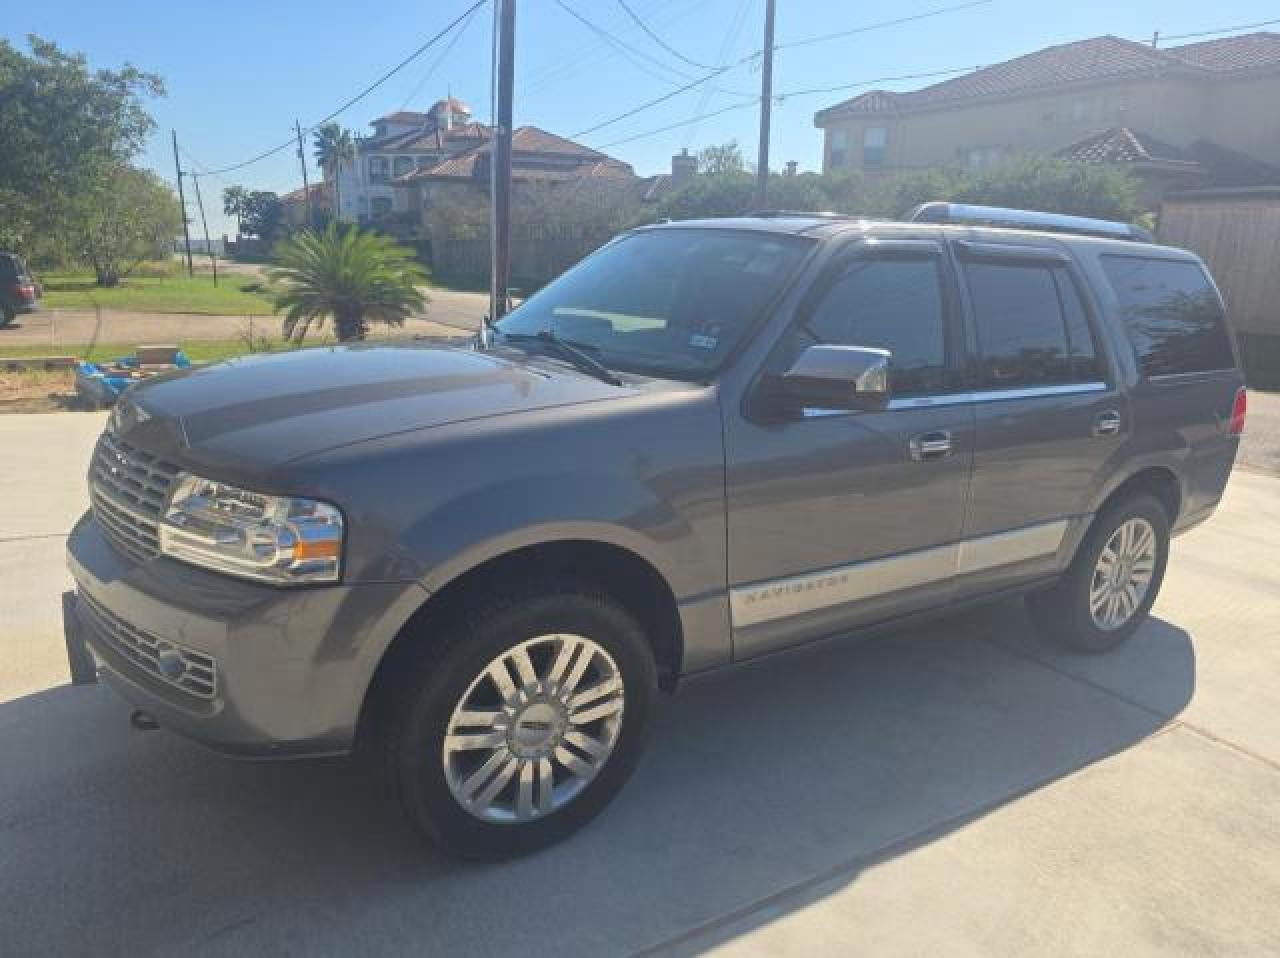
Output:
[{"left": 480, "top": 0, "right": 516, "bottom": 335}]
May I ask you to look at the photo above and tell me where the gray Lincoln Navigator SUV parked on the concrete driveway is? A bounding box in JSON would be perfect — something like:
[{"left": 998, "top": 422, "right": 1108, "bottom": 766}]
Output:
[{"left": 68, "top": 209, "right": 1244, "bottom": 858}]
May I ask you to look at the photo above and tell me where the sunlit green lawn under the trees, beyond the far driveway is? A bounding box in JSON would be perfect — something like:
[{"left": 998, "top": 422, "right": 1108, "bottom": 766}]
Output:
[{"left": 40, "top": 272, "right": 271, "bottom": 316}]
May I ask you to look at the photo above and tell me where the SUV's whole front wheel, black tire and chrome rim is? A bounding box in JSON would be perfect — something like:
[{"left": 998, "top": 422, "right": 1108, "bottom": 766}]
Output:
[{"left": 389, "top": 584, "right": 657, "bottom": 859}]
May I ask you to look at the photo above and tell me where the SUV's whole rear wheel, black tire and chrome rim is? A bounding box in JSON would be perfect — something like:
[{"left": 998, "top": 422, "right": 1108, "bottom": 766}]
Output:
[{"left": 1027, "top": 493, "right": 1169, "bottom": 652}]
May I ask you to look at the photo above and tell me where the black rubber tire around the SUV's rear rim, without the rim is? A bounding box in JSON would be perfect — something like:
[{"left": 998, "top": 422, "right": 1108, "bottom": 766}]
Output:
[{"left": 1027, "top": 493, "right": 1169, "bottom": 653}]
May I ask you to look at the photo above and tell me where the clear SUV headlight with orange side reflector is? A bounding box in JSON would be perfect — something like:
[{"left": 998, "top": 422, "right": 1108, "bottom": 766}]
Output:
[{"left": 160, "top": 473, "right": 343, "bottom": 585}]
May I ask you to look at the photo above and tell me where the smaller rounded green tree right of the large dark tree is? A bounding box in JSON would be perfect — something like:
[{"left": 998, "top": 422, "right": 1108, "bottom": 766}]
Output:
[{"left": 76, "top": 166, "right": 182, "bottom": 287}]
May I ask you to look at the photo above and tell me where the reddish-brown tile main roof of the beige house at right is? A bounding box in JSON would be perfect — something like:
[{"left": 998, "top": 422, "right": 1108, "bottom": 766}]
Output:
[{"left": 814, "top": 33, "right": 1280, "bottom": 126}]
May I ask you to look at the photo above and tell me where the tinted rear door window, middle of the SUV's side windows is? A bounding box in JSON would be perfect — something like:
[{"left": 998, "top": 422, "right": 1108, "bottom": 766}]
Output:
[{"left": 965, "top": 263, "right": 1101, "bottom": 389}]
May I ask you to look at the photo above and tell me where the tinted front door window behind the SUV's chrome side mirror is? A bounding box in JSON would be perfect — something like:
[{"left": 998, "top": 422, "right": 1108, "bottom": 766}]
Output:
[{"left": 804, "top": 257, "right": 950, "bottom": 394}]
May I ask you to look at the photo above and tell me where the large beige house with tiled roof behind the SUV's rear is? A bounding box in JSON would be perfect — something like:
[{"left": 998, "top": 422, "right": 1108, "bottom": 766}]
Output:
[{"left": 814, "top": 33, "right": 1280, "bottom": 192}]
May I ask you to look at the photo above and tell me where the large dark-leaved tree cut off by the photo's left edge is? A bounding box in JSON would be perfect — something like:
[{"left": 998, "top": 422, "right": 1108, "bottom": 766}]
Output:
[{"left": 0, "top": 36, "right": 164, "bottom": 261}]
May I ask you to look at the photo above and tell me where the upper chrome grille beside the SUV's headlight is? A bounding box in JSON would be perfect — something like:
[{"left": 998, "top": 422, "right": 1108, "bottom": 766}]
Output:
[{"left": 88, "top": 433, "right": 179, "bottom": 562}]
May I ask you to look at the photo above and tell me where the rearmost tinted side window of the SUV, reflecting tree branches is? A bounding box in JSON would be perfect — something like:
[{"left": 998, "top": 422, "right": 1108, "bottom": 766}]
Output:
[{"left": 1102, "top": 256, "right": 1235, "bottom": 377}]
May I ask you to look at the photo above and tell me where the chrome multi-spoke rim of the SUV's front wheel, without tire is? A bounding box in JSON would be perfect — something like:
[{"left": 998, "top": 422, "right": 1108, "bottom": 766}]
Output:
[{"left": 443, "top": 635, "right": 625, "bottom": 825}]
